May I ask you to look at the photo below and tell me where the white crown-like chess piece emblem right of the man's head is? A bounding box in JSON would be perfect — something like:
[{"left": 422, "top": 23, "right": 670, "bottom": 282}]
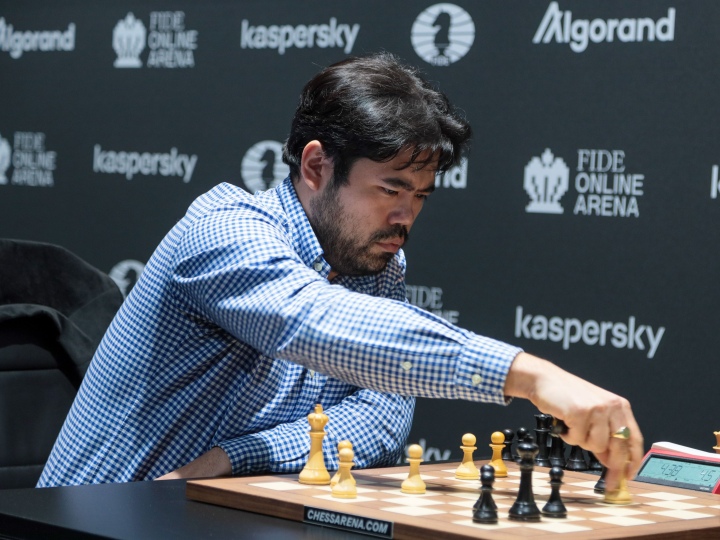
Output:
[{"left": 523, "top": 148, "right": 570, "bottom": 214}]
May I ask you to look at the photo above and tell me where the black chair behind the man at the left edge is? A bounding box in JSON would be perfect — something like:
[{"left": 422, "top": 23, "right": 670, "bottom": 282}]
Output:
[{"left": 0, "top": 239, "right": 123, "bottom": 489}]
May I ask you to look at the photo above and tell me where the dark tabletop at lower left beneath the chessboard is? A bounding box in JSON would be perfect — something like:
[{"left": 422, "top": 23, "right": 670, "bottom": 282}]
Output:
[{"left": 0, "top": 480, "right": 361, "bottom": 540}]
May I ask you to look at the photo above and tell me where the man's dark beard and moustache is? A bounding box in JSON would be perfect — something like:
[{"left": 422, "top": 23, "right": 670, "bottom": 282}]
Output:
[{"left": 310, "top": 182, "right": 408, "bottom": 276}]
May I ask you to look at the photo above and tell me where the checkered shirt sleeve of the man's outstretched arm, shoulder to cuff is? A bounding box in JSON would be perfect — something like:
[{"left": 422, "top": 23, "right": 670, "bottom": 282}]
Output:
[{"left": 174, "top": 202, "right": 520, "bottom": 404}]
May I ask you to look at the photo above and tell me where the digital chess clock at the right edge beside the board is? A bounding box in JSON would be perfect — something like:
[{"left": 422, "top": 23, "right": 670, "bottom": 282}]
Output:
[{"left": 635, "top": 445, "right": 720, "bottom": 493}]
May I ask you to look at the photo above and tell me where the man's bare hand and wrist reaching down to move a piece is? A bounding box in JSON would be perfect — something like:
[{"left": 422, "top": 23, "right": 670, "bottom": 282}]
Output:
[{"left": 505, "top": 352, "right": 644, "bottom": 489}]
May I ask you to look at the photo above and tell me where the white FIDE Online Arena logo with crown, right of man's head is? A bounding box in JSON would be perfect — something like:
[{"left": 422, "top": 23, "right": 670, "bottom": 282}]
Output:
[{"left": 524, "top": 148, "right": 645, "bottom": 217}]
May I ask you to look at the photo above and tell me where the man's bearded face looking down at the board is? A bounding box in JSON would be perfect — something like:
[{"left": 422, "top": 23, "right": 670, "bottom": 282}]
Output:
[{"left": 310, "top": 151, "right": 435, "bottom": 279}]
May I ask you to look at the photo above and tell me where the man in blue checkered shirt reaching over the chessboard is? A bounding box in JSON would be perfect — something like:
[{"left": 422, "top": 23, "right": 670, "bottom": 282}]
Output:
[{"left": 38, "top": 54, "right": 642, "bottom": 487}]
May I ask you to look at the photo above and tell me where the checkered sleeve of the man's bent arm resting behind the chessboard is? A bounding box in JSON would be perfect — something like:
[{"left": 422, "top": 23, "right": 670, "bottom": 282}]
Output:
[{"left": 217, "top": 390, "right": 415, "bottom": 475}]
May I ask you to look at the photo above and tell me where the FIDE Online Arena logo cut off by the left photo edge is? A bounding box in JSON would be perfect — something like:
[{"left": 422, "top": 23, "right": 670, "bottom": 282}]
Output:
[{"left": 0, "top": 131, "right": 57, "bottom": 187}]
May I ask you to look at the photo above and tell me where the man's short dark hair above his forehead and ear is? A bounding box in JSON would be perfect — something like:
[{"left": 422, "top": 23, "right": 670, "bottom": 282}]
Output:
[{"left": 283, "top": 53, "right": 471, "bottom": 183}]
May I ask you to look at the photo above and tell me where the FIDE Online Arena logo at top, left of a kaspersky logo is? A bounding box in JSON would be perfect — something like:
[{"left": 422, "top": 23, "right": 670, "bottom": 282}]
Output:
[{"left": 112, "top": 11, "right": 198, "bottom": 69}]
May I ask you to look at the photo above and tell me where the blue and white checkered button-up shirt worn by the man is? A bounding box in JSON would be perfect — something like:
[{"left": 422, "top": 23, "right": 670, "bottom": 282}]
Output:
[{"left": 38, "top": 179, "right": 519, "bottom": 487}]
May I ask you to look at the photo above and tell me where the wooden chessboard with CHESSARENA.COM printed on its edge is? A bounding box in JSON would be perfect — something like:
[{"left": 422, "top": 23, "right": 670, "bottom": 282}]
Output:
[{"left": 186, "top": 462, "right": 720, "bottom": 540}]
